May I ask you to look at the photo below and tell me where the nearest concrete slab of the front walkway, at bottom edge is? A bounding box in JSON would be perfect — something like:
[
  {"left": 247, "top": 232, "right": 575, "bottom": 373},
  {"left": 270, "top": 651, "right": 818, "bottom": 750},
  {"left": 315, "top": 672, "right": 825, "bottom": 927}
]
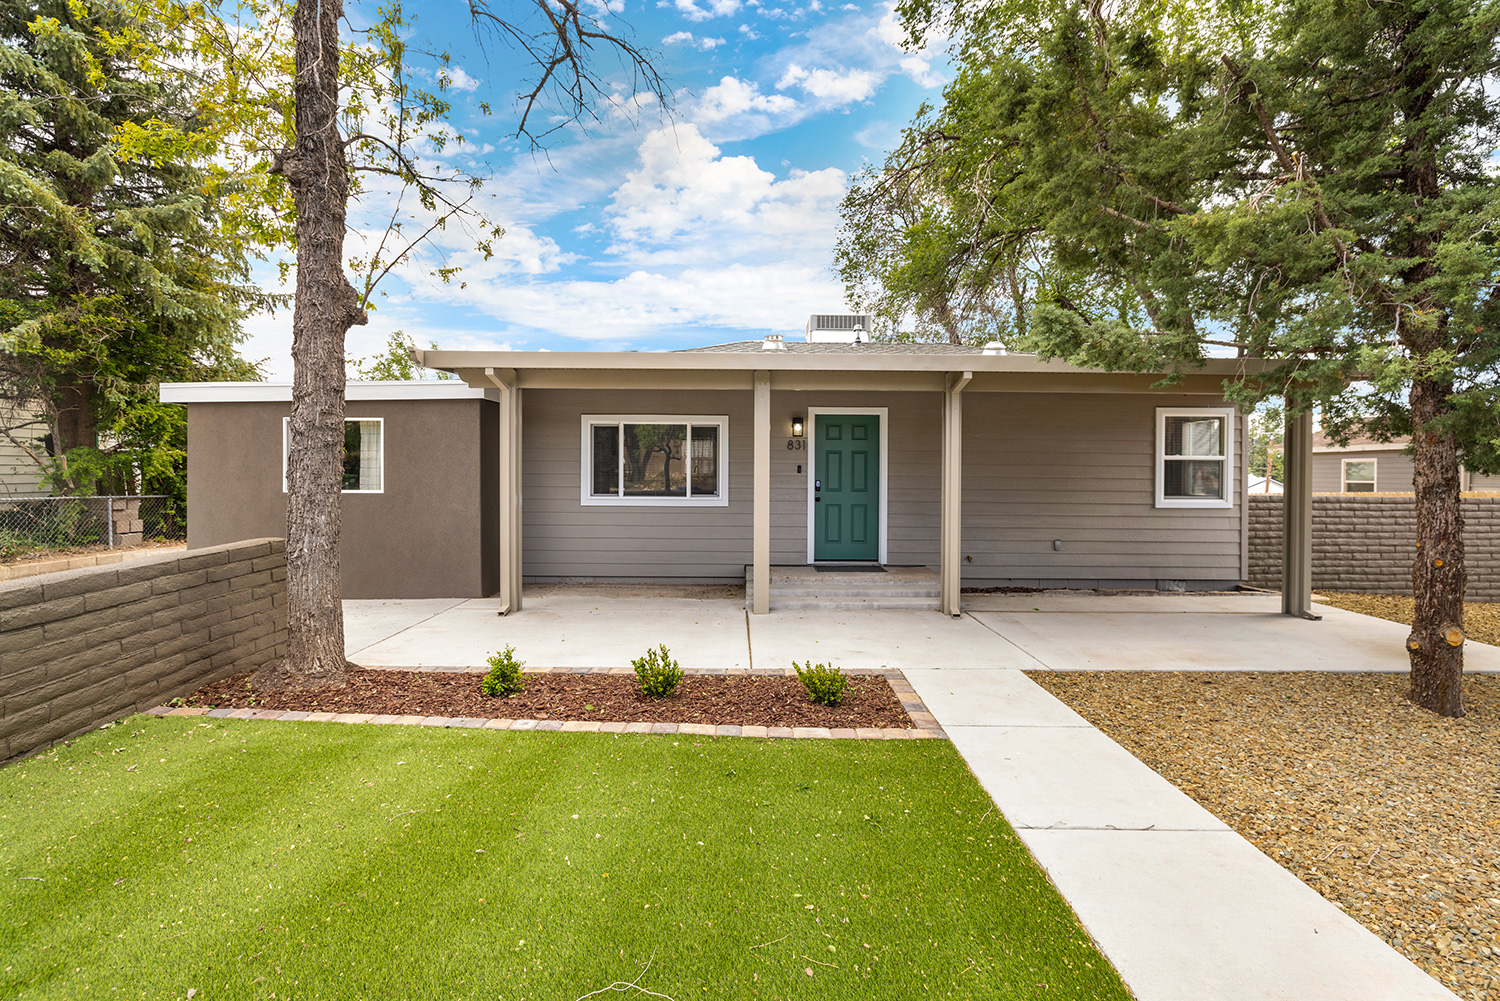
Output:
[{"left": 1017, "top": 828, "right": 1457, "bottom": 1001}]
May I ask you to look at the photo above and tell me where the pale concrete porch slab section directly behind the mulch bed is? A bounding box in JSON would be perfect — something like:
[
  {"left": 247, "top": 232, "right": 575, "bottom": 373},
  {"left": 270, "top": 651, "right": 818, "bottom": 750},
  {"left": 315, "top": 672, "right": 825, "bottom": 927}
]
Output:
[{"left": 351, "top": 590, "right": 750, "bottom": 671}]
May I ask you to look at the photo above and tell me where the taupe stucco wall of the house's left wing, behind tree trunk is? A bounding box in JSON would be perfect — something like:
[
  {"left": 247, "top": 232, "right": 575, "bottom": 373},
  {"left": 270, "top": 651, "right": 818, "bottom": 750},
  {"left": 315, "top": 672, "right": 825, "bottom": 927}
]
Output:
[{"left": 188, "top": 399, "right": 498, "bottom": 597}]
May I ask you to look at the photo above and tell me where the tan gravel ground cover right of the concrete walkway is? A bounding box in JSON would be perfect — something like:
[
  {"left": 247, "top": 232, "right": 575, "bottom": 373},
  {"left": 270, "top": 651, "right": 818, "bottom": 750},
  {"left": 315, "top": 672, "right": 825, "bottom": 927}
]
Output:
[{"left": 1029, "top": 671, "right": 1500, "bottom": 1001}]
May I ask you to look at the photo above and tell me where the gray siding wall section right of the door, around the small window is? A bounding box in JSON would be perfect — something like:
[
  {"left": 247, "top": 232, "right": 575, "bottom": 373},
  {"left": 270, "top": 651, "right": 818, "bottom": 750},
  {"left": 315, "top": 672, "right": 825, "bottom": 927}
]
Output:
[{"left": 963, "top": 393, "right": 1245, "bottom": 587}]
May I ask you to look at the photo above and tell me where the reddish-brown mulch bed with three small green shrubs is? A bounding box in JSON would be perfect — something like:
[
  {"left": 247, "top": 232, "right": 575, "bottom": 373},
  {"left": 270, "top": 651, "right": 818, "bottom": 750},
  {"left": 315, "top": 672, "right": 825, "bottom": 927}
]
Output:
[{"left": 185, "top": 668, "right": 912, "bottom": 729}]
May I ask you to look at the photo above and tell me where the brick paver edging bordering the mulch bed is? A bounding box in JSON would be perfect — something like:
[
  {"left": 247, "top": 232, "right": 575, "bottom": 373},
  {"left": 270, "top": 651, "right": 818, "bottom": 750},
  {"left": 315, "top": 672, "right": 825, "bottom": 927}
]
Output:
[{"left": 147, "top": 668, "right": 948, "bottom": 740}]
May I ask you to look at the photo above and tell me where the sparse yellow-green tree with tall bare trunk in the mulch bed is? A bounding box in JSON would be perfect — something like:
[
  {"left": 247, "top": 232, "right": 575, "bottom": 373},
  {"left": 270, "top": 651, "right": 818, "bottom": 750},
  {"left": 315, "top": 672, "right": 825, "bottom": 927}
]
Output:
[{"left": 149, "top": 0, "right": 666, "bottom": 687}]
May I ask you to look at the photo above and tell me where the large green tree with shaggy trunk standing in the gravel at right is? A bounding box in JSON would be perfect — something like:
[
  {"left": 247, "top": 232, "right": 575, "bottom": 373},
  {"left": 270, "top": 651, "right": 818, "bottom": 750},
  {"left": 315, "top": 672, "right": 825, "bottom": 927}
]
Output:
[{"left": 864, "top": 0, "right": 1500, "bottom": 716}]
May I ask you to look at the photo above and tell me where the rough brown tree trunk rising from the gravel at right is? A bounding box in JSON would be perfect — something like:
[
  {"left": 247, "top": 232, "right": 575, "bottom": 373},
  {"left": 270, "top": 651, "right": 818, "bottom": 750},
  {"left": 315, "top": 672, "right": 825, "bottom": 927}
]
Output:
[{"left": 1407, "top": 378, "right": 1467, "bottom": 716}]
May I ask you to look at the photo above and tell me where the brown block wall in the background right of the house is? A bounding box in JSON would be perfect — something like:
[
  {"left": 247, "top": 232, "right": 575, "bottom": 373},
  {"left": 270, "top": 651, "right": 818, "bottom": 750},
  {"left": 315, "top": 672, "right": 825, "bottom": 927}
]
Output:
[{"left": 1248, "top": 494, "right": 1500, "bottom": 602}]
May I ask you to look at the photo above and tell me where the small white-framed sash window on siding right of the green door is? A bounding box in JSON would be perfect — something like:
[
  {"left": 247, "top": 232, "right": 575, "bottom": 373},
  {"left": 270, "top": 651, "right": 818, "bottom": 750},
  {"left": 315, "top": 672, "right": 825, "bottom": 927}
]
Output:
[{"left": 1157, "top": 408, "right": 1235, "bottom": 507}]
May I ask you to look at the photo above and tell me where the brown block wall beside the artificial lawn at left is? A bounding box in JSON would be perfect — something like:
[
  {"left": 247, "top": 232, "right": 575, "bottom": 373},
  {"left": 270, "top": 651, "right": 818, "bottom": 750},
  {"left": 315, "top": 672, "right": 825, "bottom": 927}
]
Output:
[{"left": 0, "top": 539, "right": 287, "bottom": 761}]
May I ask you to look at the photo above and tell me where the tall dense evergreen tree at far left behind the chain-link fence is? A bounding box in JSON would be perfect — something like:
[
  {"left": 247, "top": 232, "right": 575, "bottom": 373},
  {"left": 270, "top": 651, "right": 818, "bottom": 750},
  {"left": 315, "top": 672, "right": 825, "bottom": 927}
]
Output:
[{"left": 0, "top": 0, "right": 267, "bottom": 492}]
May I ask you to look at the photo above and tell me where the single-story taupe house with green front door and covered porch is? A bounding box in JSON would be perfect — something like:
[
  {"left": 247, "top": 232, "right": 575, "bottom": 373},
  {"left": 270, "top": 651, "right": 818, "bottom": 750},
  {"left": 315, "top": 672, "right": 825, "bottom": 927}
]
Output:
[{"left": 162, "top": 315, "right": 1311, "bottom": 614}]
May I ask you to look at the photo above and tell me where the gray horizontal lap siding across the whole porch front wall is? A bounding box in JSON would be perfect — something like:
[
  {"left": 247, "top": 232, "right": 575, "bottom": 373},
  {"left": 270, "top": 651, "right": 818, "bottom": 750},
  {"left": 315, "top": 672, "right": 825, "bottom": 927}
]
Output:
[{"left": 522, "top": 390, "right": 1244, "bottom": 585}]
